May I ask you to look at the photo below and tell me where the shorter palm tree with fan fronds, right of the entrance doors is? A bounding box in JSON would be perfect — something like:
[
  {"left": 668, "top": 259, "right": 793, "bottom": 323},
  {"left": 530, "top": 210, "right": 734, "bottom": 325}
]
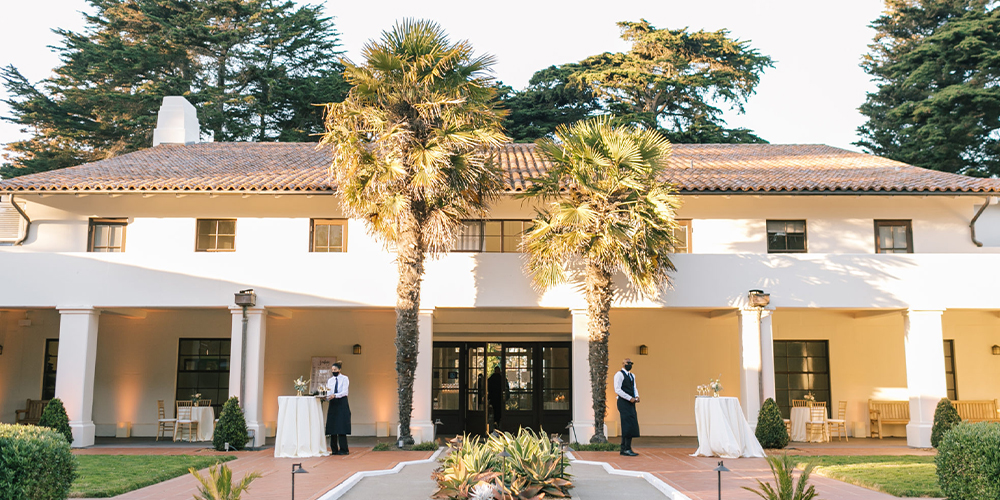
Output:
[{"left": 522, "top": 117, "right": 679, "bottom": 443}]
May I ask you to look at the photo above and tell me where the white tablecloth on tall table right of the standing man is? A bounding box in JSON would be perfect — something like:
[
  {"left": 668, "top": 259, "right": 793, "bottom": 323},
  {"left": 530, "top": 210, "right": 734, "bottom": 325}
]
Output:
[{"left": 692, "top": 397, "right": 765, "bottom": 458}]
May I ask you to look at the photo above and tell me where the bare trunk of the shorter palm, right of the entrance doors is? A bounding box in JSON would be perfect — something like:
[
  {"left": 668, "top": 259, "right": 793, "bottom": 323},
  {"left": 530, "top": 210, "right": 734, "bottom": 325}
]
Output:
[{"left": 586, "top": 261, "right": 614, "bottom": 443}]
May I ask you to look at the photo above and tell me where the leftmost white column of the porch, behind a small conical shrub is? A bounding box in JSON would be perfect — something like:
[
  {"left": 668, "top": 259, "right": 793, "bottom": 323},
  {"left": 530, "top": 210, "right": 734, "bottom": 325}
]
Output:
[{"left": 56, "top": 307, "right": 101, "bottom": 448}]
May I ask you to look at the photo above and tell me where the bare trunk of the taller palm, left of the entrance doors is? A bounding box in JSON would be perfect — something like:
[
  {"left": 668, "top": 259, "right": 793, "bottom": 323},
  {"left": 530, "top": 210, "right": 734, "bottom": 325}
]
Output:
[{"left": 396, "top": 214, "right": 424, "bottom": 444}]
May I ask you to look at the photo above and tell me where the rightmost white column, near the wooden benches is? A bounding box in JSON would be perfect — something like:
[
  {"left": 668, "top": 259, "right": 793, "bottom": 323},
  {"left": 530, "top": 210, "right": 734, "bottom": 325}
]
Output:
[{"left": 903, "top": 309, "right": 948, "bottom": 448}]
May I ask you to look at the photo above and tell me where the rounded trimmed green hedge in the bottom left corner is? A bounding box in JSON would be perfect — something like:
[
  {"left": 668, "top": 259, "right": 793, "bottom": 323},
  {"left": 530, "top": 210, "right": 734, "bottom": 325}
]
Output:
[{"left": 0, "top": 424, "right": 76, "bottom": 500}]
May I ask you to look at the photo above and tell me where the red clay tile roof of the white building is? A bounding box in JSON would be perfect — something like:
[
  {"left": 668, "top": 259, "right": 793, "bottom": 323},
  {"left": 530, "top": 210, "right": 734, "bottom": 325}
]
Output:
[{"left": 0, "top": 143, "right": 1000, "bottom": 194}]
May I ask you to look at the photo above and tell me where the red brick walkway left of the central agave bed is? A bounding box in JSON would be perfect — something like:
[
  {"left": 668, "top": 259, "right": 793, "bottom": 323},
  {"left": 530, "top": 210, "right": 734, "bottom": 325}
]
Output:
[{"left": 74, "top": 448, "right": 432, "bottom": 500}]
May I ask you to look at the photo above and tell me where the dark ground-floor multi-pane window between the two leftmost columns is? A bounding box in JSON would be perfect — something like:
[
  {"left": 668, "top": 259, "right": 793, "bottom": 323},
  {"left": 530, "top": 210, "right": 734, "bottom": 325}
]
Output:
[{"left": 176, "top": 339, "right": 230, "bottom": 415}]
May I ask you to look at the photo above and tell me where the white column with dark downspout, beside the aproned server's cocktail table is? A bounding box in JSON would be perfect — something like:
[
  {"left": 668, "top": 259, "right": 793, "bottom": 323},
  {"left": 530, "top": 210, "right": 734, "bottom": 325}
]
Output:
[{"left": 229, "top": 306, "right": 267, "bottom": 447}]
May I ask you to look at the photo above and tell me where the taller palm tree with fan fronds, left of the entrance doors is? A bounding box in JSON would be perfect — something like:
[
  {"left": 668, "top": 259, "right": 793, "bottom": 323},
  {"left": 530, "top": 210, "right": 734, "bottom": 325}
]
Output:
[{"left": 322, "top": 20, "right": 507, "bottom": 443}]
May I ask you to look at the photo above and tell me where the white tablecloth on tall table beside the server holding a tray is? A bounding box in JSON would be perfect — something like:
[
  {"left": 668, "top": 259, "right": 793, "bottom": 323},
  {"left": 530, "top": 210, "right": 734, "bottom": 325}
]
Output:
[{"left": 274, "top": 396, "right": 330, "bottom": 458}]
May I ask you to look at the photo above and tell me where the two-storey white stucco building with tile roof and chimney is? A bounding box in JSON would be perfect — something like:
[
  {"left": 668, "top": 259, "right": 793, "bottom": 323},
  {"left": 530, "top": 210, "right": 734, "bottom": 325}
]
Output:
[{"left": 0, "top": 101, "right": 1000, "bottom": 446}]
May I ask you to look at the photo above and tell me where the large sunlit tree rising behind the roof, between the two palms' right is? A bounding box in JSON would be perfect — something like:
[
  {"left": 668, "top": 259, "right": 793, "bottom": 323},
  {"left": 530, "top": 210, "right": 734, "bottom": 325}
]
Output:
[{"left": 502, "top": 20, "right": 773, "bottom": 143}]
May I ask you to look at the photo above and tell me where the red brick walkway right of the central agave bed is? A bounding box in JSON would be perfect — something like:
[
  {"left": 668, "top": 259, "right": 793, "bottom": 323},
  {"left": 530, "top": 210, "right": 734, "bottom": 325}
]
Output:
[{"left": 574, "top": 440, "right": 934, "bottom": 500}]
